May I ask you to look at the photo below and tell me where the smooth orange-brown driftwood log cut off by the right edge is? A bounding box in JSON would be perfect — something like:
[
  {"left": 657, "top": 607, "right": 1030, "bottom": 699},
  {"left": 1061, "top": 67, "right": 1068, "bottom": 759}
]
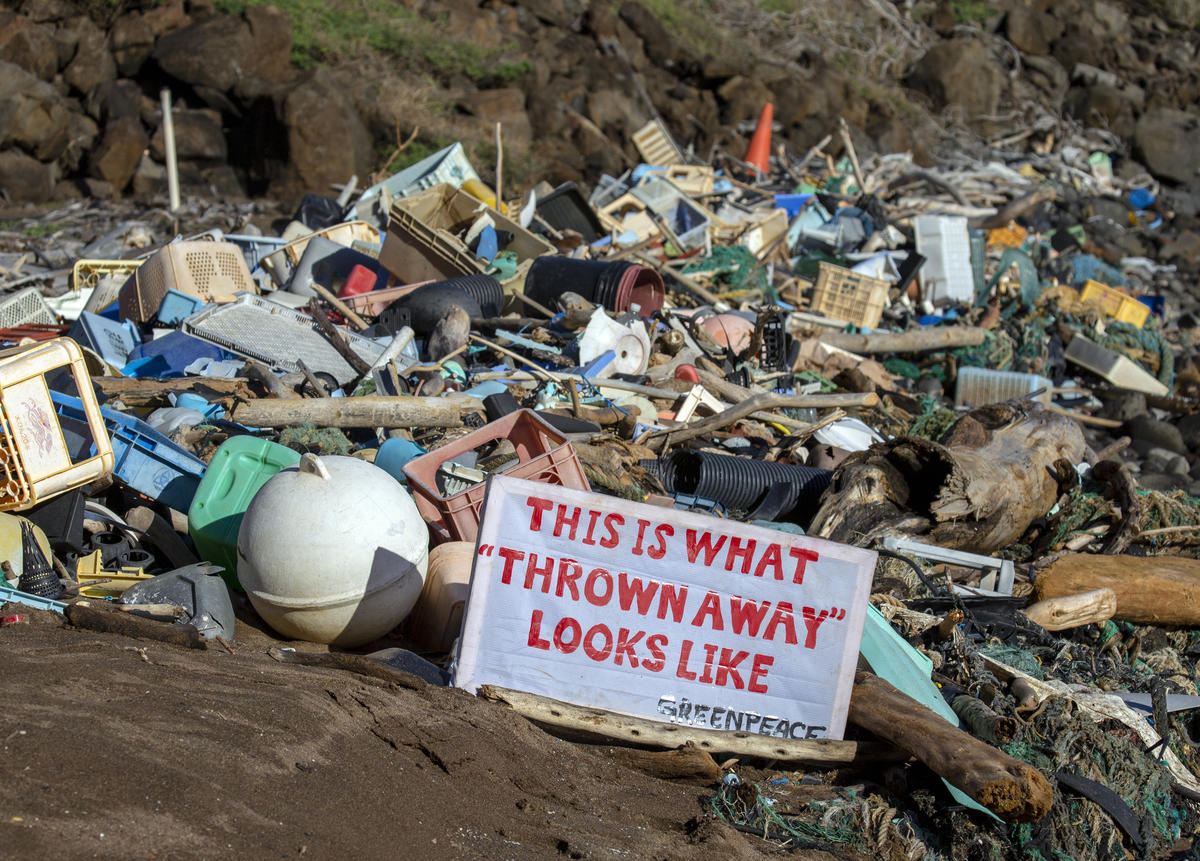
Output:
[{"left": 1033, "top": 553, "right": 1200, "bottom": 627}]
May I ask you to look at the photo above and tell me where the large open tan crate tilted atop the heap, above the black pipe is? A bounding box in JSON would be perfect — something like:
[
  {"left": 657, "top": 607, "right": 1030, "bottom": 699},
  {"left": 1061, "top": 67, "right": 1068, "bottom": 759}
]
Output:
[{"left": 379, "top": 183, "right": 558, "bottom": 290}]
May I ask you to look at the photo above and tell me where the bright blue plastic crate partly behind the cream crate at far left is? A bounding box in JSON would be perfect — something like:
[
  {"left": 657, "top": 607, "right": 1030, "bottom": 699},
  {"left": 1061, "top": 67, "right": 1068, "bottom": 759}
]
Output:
[{"left": 50, "top": 391, "right": 208, "bottom": 511}]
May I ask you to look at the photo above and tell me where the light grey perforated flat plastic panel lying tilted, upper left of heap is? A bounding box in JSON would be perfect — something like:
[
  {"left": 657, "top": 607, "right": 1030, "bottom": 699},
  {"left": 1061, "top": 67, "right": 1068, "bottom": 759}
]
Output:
[{"left": 182, "top": 294, "right": 384, "bottom": 384}]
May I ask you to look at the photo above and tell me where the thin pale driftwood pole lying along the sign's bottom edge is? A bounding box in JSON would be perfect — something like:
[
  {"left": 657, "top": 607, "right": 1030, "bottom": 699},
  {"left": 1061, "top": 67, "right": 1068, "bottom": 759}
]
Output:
[{"left": 479, "top": 685, "right": 904, "bottom": 765}]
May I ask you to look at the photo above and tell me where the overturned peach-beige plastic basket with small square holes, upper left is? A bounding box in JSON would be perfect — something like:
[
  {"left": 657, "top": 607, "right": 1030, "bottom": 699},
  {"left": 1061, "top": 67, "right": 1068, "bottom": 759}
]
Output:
[{"left": 118, "top": 240, "right": 258, "bottom": 323}]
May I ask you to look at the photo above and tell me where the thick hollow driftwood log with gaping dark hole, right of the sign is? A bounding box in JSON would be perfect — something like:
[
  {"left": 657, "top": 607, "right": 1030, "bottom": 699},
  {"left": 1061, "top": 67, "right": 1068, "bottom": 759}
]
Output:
[{"left": 809, "top": 402, "right": 1085, "bottom": 553}]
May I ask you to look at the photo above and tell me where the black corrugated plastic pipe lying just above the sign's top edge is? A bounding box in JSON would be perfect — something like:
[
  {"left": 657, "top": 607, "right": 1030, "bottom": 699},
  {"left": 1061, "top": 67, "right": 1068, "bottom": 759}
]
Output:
[{"left": 660, "top": 450, "right": 833, "bottom": 514}]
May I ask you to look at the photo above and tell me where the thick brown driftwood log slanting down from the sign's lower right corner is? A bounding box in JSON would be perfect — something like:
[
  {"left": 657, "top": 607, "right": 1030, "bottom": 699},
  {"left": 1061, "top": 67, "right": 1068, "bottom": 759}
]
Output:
[{"left": 850, "top": 670, "right": 1054, "bottom": 823}]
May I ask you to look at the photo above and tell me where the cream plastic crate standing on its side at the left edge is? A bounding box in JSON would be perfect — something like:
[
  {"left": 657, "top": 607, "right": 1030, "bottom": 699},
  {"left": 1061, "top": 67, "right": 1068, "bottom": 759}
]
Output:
[{"left": 0, "top": 338, "right": 113, "bottom": 511}]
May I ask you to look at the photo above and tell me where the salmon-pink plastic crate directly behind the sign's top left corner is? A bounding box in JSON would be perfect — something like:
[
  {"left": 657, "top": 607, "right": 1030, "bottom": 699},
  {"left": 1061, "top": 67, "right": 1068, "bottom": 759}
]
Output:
[{"left": 404, "top": 410, "right": 592, "bottom": 541}]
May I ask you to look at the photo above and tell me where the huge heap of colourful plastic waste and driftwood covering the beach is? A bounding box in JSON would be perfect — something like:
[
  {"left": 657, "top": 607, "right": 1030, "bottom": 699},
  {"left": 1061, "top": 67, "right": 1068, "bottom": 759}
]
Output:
[{"left": 0, "top": 112, "right": 1200, "bottom": 860}]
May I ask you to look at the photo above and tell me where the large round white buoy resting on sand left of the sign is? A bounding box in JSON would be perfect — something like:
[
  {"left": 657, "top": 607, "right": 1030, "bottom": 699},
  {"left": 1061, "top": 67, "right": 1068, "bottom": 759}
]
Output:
[{"left": 238, "top": 454, "right": 428, "bottom": 646}]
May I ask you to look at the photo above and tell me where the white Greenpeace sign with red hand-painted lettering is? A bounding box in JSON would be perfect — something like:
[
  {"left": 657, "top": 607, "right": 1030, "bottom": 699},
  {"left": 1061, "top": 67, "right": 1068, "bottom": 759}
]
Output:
[{"left": 455, "top": 476, "right": 876, "bottom": 739}]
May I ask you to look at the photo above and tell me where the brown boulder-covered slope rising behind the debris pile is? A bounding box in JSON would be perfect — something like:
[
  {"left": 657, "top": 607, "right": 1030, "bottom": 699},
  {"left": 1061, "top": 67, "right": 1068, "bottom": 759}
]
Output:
[{"left": 0, "top": 0, "right": 1200, "bottom": 208}]
